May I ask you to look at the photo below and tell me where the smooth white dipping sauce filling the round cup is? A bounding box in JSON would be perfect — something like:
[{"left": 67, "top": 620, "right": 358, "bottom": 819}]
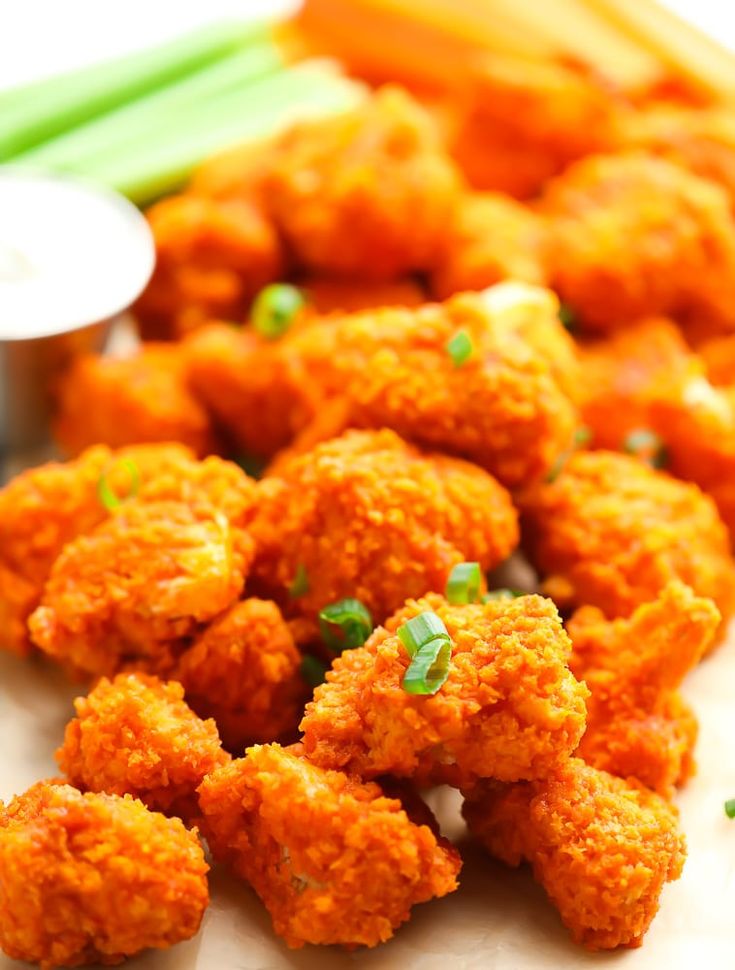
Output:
[{"left": 0, "top": 166, "right": 155, "bottom": 340}]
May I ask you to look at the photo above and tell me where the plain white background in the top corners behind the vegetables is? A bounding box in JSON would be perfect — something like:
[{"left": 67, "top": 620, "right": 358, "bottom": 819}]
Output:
[{"left": 0, "top": 0, "right": 735, "bottom": 91}]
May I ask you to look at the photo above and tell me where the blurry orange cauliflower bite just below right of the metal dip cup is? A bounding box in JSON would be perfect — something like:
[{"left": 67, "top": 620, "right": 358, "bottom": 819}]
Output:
[{"left": 54, "top": 343, "right": 216, "bottom": 456}]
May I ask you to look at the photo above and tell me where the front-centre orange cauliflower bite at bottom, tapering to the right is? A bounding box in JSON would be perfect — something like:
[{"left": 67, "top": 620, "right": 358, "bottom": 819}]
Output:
[{"left": 200, "top": 744, "right": 461, "bottom": 948}]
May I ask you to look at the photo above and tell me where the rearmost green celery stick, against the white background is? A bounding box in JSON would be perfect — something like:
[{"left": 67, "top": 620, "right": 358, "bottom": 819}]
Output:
[{"left": 0, "top": 22, "right": 269, "bottom": 162}]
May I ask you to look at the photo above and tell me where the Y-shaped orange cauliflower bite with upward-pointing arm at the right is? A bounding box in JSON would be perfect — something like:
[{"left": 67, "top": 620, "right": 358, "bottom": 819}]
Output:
[{"left": 567, "top": 583, "right": 720, "bottom": 796}]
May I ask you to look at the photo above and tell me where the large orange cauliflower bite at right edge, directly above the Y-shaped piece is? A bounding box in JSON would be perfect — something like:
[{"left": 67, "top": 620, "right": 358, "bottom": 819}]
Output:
[{"left": 520, "top": 451, "right": 735, "bottom": 619}]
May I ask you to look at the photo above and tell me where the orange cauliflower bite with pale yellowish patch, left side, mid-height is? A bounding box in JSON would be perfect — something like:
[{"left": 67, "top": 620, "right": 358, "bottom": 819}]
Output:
[{"left": 29, "top": 499, "right": 253, "bottom": 675}]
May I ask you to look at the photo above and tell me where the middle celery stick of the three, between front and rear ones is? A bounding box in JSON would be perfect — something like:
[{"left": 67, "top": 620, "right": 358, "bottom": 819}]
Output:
[{"left": 13, "top": 41, "right": 284, "bottom": 169}]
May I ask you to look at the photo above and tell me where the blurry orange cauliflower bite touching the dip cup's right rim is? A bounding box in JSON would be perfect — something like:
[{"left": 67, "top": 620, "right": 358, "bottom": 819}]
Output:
[{"left": 135, "top": 193, "right": 284, "bottom": 340}]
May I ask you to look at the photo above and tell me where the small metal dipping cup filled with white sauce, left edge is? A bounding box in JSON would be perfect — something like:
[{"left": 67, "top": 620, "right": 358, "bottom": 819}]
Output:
[{"left": 0, "top": 166, "right": 155, "bottom": 465}]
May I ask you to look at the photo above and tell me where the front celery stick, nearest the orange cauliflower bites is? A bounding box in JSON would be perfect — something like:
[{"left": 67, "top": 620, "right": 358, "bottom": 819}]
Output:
[{"left": 83, "top": 63, "right": 366, "bottom": 204}]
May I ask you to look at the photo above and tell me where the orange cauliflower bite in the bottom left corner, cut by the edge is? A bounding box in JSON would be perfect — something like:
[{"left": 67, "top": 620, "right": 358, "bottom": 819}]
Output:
[{"left": 0, "top": 782, "right": 209, "bottom": 970}]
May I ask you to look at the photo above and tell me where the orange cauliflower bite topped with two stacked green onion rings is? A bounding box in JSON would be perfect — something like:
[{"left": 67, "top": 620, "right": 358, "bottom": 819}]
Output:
[{"left": 301, "top": 593, "right": 587, "bottom": 785}]
